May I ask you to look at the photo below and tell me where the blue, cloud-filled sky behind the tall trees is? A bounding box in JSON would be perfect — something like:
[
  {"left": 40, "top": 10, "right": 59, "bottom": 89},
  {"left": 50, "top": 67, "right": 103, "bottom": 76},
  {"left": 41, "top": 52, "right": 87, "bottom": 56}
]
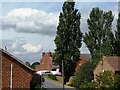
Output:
[{"left": 0, "top": 0, "right": 118, "bottom": 63}]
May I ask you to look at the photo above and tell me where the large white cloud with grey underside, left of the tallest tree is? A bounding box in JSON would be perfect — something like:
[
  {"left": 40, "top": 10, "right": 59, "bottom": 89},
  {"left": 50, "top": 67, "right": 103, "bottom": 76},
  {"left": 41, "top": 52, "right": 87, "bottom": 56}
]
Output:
[{"left": 2, "top": 8, "right": 59, "bottom": 36}]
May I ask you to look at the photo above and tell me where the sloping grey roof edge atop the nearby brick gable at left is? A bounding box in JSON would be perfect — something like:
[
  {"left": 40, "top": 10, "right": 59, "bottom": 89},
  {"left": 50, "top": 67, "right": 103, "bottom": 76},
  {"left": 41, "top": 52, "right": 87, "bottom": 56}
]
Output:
[{"left": 0, "top": 48, "right": 36, "bottom": 72}]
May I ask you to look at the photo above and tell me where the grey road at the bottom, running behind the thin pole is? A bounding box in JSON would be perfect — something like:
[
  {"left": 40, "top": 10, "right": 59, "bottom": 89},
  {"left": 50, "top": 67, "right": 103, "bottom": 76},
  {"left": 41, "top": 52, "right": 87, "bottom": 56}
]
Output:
[{"left": 43, "top": 79, "right": 76, "bottom": 90}]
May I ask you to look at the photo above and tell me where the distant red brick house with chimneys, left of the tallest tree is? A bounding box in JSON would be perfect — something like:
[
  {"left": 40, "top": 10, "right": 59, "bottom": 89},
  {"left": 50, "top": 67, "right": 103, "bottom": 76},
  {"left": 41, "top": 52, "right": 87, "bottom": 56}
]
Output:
[{"left": 35, "top": 51, "right": 61, "bottom": 75}]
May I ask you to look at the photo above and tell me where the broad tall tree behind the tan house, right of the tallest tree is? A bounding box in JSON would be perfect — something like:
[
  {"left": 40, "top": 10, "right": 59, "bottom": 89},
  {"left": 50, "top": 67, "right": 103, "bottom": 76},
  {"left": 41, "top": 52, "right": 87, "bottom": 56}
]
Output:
[{"left": 83, "top": 8, "right": 114, "bottom": 59}]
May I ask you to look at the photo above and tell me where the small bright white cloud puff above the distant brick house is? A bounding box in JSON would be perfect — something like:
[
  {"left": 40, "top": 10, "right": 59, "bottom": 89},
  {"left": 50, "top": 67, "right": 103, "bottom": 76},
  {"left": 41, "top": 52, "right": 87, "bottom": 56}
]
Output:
[{"left": 22, "top": 43, "right": 42, "bottom": 53}]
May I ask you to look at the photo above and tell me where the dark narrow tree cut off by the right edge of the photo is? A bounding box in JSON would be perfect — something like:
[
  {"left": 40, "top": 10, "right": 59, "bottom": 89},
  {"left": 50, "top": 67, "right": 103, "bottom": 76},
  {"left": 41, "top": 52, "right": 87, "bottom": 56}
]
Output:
[{"left": 115, "top": 12, "right": 120, "bottom": 56}]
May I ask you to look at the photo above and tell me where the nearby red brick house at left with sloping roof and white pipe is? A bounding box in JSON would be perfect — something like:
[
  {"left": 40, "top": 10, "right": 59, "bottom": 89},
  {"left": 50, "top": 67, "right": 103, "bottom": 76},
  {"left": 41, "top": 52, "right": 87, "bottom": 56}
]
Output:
[{"left": 0, "top": 49, "right": 35, "bottom": 90}]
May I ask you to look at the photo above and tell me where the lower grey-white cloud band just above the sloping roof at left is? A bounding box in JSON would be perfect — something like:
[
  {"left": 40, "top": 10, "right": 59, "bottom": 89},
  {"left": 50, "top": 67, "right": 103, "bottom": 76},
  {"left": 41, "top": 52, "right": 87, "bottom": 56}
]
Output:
[{"left": 2, "top": 40, "right": 43, "bottom": 55}]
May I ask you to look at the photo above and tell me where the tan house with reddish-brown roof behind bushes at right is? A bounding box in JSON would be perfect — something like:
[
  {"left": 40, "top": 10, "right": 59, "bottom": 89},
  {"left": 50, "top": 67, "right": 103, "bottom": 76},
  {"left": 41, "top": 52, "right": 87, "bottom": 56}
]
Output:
[{"left": 93, "top": 56, "right": 120, "bottom": 79}]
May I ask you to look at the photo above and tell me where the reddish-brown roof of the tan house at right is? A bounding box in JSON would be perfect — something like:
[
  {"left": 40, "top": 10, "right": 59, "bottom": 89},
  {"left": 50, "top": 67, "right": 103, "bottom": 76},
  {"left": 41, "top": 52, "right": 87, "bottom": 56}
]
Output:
[{"left": 103, "top": 56, "right": 120, "bottom": 71}]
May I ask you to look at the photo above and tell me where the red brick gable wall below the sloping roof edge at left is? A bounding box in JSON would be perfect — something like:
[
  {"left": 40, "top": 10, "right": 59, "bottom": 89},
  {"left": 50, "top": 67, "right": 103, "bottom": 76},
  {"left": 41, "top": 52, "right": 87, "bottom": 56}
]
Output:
[{"left": 2, "top": 51, "right": 33, "bottom": 88}]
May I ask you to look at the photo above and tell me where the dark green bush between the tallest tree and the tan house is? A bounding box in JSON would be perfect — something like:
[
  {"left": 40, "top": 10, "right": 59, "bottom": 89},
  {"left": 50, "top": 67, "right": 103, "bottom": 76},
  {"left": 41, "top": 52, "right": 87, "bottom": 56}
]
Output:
[{"left": 74, "top": 60, "right": 98, "bottom": 88}]
